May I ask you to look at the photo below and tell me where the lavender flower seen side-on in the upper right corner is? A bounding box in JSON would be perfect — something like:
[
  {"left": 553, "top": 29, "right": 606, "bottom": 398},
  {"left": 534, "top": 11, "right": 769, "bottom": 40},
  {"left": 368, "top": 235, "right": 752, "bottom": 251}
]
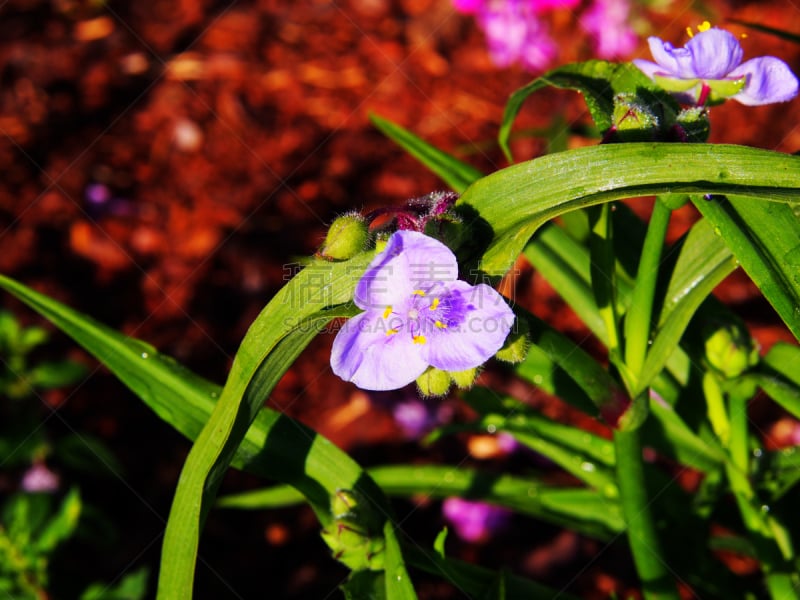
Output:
[{"left": 633, "top": 23, "right": 798, "bottom": 106}]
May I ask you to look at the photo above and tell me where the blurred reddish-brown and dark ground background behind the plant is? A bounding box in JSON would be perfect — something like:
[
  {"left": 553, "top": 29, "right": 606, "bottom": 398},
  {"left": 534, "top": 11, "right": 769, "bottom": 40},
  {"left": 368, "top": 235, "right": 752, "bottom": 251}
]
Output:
[{"left": 0, "top": 0, "right": 800, "bottom": 598}]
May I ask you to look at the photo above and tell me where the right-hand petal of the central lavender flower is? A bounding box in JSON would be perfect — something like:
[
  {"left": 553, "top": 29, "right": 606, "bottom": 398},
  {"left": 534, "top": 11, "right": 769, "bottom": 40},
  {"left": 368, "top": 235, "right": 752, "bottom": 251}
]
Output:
[{"left": 420, "top": 281, "right": 514, "bottom": 371}]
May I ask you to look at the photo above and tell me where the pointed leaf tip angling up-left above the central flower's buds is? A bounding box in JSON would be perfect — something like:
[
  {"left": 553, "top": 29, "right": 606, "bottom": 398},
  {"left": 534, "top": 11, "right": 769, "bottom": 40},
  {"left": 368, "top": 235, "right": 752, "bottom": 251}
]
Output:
[{"left": 369, "top": 115, "right": 483, "bottom": 193}]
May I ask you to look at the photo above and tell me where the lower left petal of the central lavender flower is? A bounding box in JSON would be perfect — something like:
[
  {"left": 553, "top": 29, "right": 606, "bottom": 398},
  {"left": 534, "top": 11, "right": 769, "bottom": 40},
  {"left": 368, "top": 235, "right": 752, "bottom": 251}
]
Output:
[{"left": 331, "top": 311, "right": 428, "bottom": 390}]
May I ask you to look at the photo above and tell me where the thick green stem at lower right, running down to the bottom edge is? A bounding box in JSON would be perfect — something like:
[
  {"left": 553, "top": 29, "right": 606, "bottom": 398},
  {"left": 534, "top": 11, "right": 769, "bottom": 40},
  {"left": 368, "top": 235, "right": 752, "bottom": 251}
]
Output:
[{"left": 614, "top": 429, "right": 680, "bottom": 600}]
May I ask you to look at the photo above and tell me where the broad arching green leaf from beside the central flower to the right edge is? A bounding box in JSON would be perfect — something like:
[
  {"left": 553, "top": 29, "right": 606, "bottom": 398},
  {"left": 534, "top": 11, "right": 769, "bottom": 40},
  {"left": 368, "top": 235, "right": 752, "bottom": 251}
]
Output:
[{"left": 457, "top": 143, "right": 800, "bottom": 275}]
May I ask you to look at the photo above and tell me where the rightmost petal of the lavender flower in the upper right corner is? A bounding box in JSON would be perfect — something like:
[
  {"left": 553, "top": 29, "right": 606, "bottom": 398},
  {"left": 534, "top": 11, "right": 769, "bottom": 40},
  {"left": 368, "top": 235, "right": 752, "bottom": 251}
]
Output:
[{"left": 730, "top": 56, "right": 797, "bottom": 106}]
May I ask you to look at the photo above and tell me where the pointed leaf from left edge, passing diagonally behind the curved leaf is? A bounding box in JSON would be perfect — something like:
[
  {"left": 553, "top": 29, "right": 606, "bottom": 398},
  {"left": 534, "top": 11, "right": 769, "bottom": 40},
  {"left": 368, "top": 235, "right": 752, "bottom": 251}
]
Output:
[{"left": 0, "top": 276, "right": 412, "bottom": 596}]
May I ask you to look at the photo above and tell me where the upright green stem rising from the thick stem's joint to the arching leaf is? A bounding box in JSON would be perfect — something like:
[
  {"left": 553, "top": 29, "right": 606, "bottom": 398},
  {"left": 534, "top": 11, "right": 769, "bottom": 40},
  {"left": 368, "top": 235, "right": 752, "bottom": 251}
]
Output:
[{"left": 624, "top": 200, "right": 672, "bottom": 396}]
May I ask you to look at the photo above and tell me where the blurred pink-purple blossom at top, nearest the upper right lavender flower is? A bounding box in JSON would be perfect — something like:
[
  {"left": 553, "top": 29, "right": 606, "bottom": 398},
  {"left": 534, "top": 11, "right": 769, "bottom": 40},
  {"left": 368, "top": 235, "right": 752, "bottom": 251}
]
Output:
[{"left": 580, "top": 0, "right": 639, "bottom": 58}]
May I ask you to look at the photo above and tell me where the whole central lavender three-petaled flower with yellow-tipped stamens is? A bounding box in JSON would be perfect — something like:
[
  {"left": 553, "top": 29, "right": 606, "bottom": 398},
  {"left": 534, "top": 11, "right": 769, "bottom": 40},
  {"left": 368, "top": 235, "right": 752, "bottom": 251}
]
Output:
[{"left": 331, "top": 231, "right": 514, "bottom": 390}]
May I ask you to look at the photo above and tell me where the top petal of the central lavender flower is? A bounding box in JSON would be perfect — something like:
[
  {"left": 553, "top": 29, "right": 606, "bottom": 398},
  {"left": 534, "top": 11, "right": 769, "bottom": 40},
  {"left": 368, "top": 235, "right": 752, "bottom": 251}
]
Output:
[{"left": 354, "top": 231, "right": 458, "bottom": 309}]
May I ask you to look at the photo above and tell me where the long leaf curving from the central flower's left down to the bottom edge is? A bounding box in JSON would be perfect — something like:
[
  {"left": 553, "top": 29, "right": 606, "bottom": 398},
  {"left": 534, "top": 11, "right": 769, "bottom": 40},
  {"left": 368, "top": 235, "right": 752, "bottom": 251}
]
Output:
[{"left": 158, "top": 253, "right": 392, "bottom": 599}]
